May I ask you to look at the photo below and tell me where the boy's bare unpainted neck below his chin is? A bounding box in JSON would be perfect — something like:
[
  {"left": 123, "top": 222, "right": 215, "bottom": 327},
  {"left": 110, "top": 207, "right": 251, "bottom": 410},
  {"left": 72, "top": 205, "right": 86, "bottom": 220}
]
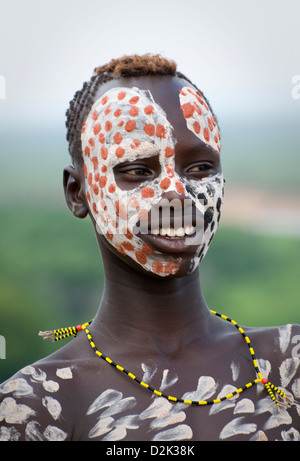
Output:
[{"left": 93, "top": 243, "right": 211, "bottom": 350}]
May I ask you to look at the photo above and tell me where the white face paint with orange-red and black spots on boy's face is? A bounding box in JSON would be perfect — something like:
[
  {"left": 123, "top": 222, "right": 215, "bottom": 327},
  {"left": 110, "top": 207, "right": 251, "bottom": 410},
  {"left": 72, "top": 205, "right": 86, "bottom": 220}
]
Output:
[{"left": 81, "top": 87, "right": 223, "bottom": 276}]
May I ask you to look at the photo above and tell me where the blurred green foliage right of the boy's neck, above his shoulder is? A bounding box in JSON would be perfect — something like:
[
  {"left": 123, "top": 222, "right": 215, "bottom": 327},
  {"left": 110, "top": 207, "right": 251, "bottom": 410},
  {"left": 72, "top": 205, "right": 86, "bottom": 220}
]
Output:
[{"left": 200, "top": 225, "right": 300, "bottom": 326}]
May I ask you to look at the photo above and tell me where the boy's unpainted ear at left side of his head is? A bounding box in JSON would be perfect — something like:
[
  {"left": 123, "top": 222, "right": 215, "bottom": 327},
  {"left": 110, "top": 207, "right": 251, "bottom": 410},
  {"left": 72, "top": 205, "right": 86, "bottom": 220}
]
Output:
[{"left": 63, "top": 165, "right": 89, "bottom": 218}]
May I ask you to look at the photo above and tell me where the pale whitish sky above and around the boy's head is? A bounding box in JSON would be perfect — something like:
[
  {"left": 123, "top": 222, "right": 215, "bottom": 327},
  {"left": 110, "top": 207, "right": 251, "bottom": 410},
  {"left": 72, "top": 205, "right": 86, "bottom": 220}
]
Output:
[{"left": 0, "top": 0, "right": 300, "bottom": 123}]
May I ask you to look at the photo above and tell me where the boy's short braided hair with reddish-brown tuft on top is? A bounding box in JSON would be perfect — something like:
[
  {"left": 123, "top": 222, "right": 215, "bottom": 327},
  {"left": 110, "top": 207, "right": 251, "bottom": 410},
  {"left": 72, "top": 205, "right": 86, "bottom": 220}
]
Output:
[{"left": 66, "top": 54, "right": 216, "bottom": 167}]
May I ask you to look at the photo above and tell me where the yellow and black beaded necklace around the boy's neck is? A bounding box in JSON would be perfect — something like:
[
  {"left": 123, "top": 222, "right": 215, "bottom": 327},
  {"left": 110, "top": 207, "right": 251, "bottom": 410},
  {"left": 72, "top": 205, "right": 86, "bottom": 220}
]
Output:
[{"left": 39, "top": 310, "right": 286, "bottom": 406}]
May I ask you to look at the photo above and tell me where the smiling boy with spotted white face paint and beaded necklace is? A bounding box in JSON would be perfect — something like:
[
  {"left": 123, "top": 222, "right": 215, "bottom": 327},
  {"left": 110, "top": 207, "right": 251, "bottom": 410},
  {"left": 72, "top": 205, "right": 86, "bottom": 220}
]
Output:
[{"left": 0, "top": 55, "right": 300, "bottom": 441}]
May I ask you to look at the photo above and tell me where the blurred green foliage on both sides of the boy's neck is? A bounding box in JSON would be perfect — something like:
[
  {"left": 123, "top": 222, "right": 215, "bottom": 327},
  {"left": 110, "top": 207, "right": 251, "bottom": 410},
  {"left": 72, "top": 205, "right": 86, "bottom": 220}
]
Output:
[{"left": 0, "top": 204, "right": 300, "bottom": 382}]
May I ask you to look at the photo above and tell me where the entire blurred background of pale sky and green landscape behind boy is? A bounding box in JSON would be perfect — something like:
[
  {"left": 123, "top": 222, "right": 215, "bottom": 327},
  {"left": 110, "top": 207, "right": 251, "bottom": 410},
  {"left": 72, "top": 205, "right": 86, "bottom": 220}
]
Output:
[{"left": 0, "top": 0, "right": 300, "bottom": 382}]
